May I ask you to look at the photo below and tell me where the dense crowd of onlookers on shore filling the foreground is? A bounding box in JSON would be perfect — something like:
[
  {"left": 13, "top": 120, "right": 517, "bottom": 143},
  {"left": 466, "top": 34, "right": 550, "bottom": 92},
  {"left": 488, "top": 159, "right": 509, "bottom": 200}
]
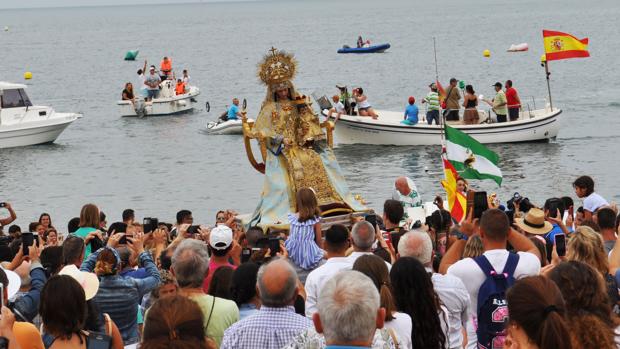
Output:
[{"left": 0, "top": 176, "right": 620, "bottom": 349}]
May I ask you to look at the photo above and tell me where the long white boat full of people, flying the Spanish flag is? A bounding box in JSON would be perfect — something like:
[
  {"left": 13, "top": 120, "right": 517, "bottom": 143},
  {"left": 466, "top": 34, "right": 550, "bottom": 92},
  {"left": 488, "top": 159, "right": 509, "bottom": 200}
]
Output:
[{"left": 323, "top": 106, "right": 562, "bottom": 145}]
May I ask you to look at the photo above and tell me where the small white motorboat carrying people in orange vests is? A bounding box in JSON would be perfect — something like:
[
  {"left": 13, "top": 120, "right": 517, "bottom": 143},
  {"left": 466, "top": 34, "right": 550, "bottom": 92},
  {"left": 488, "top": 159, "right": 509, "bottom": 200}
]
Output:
[{"left": 116, "top": 80, "right": 200, "bottom": 116}]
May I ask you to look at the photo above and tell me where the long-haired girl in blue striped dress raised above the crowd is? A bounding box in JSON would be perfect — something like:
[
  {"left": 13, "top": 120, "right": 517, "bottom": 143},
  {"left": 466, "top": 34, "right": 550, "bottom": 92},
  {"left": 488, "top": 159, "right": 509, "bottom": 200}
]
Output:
[{"left": 285, "top": 188, "right": 323, "bottom": 270}]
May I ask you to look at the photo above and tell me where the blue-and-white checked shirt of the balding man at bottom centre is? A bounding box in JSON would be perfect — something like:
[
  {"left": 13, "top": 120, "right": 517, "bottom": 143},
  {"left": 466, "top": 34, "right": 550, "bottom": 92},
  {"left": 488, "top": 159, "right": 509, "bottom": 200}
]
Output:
[{"left": 220, "top": 306, "right": 312, "bottom": 349}]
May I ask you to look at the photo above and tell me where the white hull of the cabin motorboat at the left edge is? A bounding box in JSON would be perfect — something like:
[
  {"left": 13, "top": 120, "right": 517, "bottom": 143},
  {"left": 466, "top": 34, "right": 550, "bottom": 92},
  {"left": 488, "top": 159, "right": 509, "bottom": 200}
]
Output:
[{"left": 0, "top": 114, "right": 77, "bottom": 149}]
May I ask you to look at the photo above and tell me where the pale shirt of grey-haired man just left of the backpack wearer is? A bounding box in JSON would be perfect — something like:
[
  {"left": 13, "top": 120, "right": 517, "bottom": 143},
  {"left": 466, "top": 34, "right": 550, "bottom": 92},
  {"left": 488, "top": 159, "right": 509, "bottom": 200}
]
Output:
[{"left": 427, "top": 269, "right": 471, "bottom": 349}]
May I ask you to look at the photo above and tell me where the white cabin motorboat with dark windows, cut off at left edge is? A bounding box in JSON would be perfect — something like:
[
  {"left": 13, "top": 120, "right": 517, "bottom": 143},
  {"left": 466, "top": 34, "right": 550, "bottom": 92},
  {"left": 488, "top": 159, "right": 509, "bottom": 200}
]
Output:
[{"left": 0, "top": 82, "right": 81, "bottom": 149}]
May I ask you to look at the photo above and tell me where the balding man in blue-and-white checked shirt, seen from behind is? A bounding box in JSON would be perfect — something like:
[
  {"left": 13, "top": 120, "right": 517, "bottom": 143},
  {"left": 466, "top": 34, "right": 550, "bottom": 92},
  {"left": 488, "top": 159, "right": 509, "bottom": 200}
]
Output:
[{"left": 220, "top": 259, "right": 312, "bottom": 349}]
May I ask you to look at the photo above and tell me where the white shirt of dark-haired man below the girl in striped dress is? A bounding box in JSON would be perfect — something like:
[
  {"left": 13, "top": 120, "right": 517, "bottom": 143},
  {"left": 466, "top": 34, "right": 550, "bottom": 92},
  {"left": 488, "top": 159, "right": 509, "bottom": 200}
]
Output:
[{"left": 304, "top": 257, "right": 353, "bottom": 317}]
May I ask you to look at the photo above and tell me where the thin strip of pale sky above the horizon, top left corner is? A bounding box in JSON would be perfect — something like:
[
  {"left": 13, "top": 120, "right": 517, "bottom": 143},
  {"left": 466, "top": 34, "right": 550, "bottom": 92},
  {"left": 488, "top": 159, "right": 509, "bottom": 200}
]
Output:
[{"left": 0, "top": 0, "right": 249, "bottom": 9}]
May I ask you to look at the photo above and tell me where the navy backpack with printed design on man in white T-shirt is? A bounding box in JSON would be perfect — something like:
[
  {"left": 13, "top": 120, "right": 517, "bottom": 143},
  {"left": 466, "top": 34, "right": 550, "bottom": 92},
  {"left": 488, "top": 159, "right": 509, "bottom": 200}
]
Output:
[{"left": 474, "top": 253, "right": 519, "bottom": 349}]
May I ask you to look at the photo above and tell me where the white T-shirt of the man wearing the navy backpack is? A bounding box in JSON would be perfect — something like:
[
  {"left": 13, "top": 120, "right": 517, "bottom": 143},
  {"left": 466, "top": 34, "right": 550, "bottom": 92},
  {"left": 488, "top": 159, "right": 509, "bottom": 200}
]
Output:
[{"left": 448, "top": 249, "right": 540, "bottom": 346}]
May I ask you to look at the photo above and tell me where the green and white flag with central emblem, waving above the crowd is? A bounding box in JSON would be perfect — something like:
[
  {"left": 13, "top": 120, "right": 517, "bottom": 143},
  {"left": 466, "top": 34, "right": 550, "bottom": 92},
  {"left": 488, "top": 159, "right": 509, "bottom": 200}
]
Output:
[{"left": 446, "top": 125, "right": 502, "bottom": 185}]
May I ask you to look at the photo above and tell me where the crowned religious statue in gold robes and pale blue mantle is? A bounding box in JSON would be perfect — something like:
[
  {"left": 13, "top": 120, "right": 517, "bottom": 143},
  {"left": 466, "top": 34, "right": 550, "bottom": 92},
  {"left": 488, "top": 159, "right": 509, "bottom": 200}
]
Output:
[{"left": 244, "top": 48, "right": 366, "bottom": 227}]
